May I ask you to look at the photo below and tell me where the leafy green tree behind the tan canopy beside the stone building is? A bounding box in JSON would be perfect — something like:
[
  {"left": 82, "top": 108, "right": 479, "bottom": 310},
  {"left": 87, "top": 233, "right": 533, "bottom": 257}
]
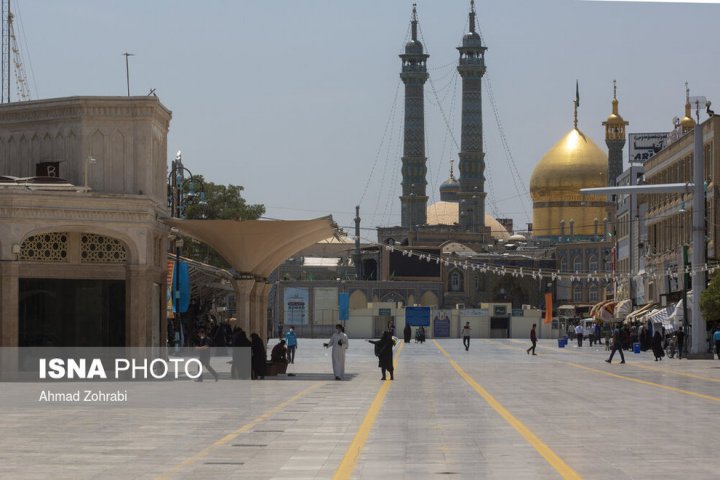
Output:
[{"left": 176, "top": 175, "right": 265, "bottom": 268}]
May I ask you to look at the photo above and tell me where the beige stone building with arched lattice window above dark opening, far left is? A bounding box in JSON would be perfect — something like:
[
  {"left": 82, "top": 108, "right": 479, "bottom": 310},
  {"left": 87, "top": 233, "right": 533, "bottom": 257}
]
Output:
[{"left": 0, "top": 97, "right": 171, "bottom": 346}]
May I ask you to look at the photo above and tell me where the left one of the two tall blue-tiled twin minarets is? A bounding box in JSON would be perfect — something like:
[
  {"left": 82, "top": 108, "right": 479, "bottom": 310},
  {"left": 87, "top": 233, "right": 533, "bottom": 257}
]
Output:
[{"left": 400, "top": 4, "right": 429, "bottom": 228}]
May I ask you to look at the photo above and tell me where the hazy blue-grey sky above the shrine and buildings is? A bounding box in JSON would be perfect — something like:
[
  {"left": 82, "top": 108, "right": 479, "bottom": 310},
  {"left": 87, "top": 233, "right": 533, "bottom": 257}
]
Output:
[{"left": 14, "top": 0, "right": 720, "bottom": 239}]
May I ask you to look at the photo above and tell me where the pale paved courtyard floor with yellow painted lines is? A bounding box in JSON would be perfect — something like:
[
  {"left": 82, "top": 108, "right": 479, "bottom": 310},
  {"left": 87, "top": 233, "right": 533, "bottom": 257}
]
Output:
[{"left": 0, "top": 339, "right": 720, "bottom": 480}]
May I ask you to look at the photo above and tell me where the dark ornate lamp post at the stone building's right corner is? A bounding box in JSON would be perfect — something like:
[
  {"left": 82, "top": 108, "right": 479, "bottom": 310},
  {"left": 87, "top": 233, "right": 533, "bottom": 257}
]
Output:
[{"left": 168, "top": 150, "right": 207, "bottom": 345}]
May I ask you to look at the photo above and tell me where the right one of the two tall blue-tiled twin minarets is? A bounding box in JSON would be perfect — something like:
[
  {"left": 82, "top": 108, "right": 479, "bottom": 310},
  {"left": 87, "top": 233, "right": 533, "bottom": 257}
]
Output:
[{"left": 458, "top": 0, "right": 487, "bottom": 232}]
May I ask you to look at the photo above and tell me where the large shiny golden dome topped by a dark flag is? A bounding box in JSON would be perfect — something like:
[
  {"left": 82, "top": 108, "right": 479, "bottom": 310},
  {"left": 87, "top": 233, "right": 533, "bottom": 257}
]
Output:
[{"left": 530, "top": 128, "right": 608, "bottom": 202}]
